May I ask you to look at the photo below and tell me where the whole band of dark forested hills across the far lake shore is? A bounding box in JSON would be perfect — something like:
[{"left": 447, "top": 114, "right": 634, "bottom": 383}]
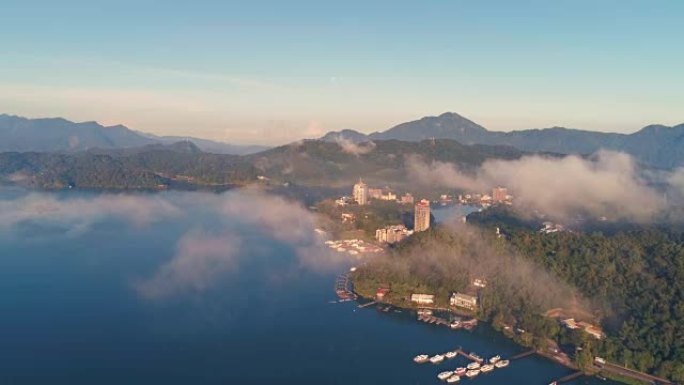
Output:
[{"left": 0, "top": 140, "right": 523, "bottom": 188}]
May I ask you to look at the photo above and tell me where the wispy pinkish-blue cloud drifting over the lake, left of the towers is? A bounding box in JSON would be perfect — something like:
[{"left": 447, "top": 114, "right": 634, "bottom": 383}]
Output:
[{"left": 135, "top": 189, "right": 347, "bottom": 299}]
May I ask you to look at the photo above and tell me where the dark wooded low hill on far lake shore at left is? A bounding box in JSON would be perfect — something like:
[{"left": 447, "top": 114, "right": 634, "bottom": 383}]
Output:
[{"left": 0, "top": 142, "right": 257, "bottom": 189}]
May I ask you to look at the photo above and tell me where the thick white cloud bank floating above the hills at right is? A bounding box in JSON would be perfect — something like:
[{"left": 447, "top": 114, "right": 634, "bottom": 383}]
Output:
[{"left": 407, "top": 151, "right": 664, "bottom": 222}]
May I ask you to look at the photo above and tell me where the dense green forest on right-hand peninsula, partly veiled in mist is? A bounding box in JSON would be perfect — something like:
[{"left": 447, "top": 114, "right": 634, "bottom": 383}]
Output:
[{"left": 354, "top": 213, "right": 684, "bottom": 382}]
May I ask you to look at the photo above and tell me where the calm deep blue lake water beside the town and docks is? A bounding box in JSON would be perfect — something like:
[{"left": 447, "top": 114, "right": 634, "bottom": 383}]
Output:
[{"left": 0, "top": 189, "right": 620, "bottom": 385}]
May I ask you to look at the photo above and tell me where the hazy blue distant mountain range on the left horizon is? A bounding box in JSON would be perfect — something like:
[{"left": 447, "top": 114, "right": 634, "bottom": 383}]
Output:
[{"left": 0, "top": 114, "right": 268, "bottom": 155}]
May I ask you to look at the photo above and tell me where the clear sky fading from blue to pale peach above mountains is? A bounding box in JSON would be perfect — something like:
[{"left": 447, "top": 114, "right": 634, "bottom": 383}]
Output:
[{"left": 0, "top": 0, "right": 684, "bottom": 145}]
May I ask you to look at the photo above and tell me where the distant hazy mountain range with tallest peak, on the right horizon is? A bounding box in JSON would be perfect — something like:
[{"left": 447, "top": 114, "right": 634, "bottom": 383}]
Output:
[{"left": 321, "top": 112, "right": 684, "bottom": 169}]
